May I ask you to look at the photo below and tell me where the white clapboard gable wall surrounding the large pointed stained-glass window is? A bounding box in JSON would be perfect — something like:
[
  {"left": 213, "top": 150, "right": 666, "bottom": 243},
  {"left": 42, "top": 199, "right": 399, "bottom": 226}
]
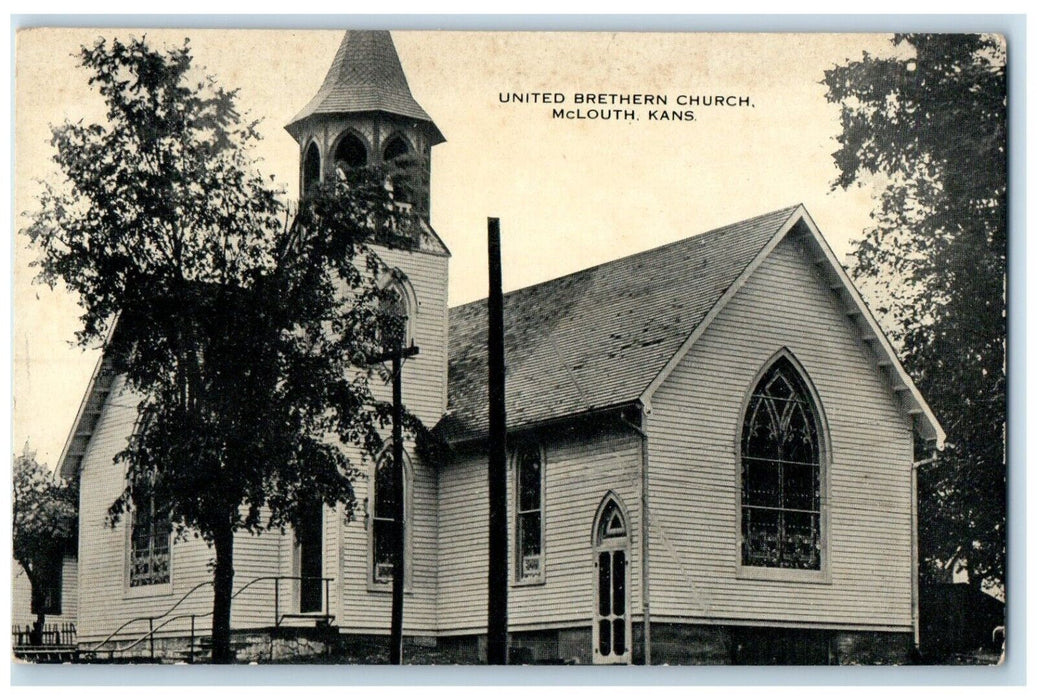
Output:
[{"left": 648, "top": 241, "right": 913, "bottom": 629}]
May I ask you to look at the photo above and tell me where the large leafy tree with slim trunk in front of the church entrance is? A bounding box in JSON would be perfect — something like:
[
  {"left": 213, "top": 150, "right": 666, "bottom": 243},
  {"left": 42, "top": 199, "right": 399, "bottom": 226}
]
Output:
[{"left": 26, "top": 39, "right": 421, "bottom": 662}]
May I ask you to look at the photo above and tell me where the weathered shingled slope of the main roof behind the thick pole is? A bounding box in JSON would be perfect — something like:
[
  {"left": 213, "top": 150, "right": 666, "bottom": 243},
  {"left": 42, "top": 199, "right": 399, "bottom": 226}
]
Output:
[{"left": 441, "top": 206, "right": 797, "bottom": 440}]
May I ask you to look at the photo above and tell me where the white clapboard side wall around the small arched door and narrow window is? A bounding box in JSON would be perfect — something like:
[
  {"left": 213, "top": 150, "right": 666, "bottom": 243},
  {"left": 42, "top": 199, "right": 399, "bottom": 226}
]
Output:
[{"left": 439, "top": 430, "right": 641, "bottom": 635}]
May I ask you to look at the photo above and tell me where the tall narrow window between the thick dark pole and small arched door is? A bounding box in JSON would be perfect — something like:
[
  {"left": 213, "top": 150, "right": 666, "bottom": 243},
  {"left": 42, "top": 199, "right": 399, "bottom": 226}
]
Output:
[{"left": 514, "top": 444, "right": 543, "bottom": 583}]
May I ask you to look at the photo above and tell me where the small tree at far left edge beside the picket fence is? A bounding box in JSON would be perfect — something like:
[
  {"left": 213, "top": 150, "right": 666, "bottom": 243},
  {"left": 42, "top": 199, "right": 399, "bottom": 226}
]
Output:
[{"left": 11, "top": 447, "right": 79, "bottom": 644}]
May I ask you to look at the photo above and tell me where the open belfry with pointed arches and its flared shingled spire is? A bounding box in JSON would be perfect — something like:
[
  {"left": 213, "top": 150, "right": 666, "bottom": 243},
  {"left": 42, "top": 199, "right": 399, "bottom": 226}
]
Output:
[{"left": 285, "top": 31, "right": 446, "bottom": 221}]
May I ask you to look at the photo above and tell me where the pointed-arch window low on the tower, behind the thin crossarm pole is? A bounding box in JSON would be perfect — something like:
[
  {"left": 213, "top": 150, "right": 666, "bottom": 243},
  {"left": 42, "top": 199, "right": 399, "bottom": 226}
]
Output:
[{"left": 368, "top": 445, "right": 411, "bottom": 587}]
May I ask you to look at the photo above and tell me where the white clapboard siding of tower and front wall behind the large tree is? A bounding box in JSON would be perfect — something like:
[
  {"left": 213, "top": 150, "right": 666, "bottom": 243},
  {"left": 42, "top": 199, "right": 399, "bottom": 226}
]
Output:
[{"left": 71, "top": 243, "right": 448, "bottom": 641}]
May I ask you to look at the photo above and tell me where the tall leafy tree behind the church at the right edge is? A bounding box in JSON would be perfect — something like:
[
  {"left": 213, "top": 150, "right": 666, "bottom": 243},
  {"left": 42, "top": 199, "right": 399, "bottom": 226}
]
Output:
[{"left": 824, "top": 34, "right": 1007, "bottom": 587}]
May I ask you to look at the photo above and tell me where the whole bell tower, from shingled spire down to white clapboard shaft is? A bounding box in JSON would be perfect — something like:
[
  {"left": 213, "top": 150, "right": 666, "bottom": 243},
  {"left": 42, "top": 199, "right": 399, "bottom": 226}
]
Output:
[{"left": 285, "top": 31, "right": 450, "bottom": 429}]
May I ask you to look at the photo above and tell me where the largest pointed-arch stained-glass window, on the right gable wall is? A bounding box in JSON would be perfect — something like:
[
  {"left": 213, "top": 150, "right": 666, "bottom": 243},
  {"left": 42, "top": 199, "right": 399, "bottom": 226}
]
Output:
[{"left": 741, "top": 356, "right": 823, "bottom": 570}]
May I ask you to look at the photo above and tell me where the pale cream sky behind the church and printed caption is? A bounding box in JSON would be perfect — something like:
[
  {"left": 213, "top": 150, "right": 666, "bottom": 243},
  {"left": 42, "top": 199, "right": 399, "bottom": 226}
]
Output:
[{"left": 11, "top": 29, "right": 893, "bottom": 466}]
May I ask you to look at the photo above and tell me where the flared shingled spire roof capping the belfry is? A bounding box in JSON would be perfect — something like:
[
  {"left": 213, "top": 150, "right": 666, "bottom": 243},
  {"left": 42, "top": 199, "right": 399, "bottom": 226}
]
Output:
[{"left": 285, "top": 30, "right": 445, "bottom": 145}]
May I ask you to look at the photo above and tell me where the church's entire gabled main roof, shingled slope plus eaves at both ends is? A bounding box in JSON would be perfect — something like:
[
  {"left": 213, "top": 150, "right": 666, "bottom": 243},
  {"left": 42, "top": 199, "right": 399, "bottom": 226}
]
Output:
[{"left": 58, "top": 205, "right": 946, "bottom": 470}]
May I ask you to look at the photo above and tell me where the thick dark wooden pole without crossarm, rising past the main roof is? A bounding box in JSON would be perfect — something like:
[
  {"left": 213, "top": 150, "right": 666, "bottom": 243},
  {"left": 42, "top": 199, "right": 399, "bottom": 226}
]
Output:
[{"left": 486, "top": 219, "right": 508, "bottom": 665}]
